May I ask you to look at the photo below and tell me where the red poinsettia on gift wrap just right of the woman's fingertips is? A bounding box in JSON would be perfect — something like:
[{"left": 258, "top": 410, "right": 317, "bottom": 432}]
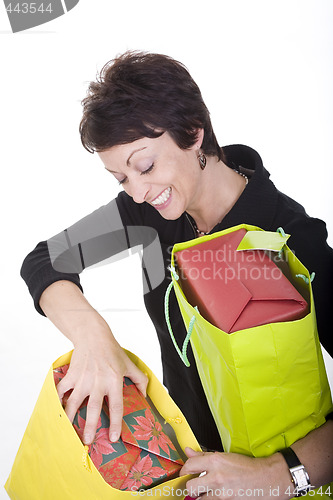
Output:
[{"left": 133, "top": 410, "right": 176, "bottom": 456}]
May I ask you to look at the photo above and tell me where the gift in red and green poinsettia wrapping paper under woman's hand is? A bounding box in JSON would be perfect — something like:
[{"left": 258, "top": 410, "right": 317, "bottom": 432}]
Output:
[{"left": 54, "top": 365, "right": 183, "bottom": 491}]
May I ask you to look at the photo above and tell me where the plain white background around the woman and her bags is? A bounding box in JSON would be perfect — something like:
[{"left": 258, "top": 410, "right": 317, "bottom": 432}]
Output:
[{"left": 0, "top": 0, "right": 333, "bottom": 500}]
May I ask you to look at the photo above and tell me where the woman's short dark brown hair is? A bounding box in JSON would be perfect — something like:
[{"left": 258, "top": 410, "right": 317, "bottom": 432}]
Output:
[{"left": 80, "top": 51, "right": 223, "bottom": 160}]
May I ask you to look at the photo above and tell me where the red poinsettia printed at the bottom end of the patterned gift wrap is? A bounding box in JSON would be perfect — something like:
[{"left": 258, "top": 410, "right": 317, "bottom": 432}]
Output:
[{"left": 121, "top": 455, "right": 165, "bottom": 491}]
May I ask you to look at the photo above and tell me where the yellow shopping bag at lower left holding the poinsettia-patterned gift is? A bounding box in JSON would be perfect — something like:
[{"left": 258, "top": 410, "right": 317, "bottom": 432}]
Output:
[{"left": 5, "top": 351, "right": 200, "bottom": 500}]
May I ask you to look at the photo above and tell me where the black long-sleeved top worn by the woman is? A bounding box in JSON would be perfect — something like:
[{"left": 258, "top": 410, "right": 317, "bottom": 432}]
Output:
[{"left": 21, "top": 145, "right": 333, "bottom": 450}]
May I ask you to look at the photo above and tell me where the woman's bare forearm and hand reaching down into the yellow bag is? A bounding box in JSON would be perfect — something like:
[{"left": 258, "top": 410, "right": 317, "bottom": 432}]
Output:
[{"left": 39, "top": 280, "right": 148, "bottom": 444}]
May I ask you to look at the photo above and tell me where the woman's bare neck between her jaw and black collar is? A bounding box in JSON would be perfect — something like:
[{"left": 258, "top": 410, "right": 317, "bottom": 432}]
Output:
[{"left": 187, "top": 157, "right": 246, "bottom": 233}]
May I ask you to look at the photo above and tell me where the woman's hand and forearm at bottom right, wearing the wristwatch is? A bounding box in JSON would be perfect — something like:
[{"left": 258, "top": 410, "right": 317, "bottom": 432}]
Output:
[{"left": 181, "top": 421, "right": 333, "bottom": 500}]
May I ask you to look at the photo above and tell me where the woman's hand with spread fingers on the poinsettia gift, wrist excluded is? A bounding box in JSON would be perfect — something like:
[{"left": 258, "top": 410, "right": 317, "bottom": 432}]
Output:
[{"left": 57, "top": 324, "right": 148, "bottom": 445}]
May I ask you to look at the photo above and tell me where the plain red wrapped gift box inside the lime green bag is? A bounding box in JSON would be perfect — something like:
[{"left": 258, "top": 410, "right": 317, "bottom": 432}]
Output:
[{"left": 175, "top": 229, "right": 308, "bottom": 333}]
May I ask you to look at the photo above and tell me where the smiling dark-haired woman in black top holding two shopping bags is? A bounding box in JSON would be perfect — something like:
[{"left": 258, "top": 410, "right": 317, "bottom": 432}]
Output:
[{"left": 22, "top": 53, "right": 333, "bottom": 497}]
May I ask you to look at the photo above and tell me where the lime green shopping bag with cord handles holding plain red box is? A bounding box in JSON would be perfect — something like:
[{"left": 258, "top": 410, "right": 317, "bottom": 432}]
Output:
[{"left": 166, "top": 224, "right": 332, "bottom": 457}]
